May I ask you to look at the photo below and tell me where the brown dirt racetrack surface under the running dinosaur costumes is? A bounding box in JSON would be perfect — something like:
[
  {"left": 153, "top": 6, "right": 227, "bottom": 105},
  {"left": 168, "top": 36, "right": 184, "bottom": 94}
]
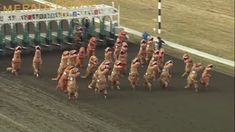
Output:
[{"left": 0, "top": 44, "right": 234, "bottom": 132}]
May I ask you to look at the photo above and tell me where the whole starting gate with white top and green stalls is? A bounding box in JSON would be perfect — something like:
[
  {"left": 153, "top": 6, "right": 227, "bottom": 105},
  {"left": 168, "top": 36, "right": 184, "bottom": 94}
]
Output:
[{"left": 0, "top": 4, "right": 119, "bottom": 50}]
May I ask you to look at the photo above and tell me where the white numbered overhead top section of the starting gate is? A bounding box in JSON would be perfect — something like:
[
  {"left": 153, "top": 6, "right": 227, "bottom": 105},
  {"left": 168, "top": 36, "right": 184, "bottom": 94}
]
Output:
[{"left": 0, "top": 4, "right": 119, "bottom": 30}]
